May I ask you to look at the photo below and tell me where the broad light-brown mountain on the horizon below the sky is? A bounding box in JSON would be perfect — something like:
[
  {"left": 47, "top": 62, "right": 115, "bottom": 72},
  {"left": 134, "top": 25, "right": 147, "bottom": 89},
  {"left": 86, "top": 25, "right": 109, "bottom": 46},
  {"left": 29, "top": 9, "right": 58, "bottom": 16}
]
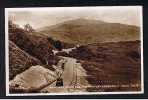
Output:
[{"left": 38, "top": 18, "right": 140, "bottom": 44}]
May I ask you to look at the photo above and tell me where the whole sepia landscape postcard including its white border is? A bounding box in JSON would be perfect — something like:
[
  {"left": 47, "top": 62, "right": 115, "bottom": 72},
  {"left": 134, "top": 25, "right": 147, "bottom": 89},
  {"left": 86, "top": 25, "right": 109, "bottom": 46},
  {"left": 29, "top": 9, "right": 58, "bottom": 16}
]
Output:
[{"left": 5, "top": 6, "right": 144, "bottom": 96}]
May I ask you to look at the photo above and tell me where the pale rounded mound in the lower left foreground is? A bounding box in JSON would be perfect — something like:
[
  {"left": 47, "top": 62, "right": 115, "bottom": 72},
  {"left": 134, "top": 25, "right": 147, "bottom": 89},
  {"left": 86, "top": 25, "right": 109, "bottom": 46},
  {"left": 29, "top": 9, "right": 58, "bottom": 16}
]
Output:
[{"left": 9, "top": 65, "right": 56, "bottom": 93}]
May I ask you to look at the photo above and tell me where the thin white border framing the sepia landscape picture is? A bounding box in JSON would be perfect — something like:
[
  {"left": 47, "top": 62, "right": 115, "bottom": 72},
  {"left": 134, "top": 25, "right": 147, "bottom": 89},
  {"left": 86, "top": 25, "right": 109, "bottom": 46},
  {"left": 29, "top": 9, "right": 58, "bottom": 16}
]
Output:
[{"left": 5, "top": 6, "right": 144, "bottom": 96}]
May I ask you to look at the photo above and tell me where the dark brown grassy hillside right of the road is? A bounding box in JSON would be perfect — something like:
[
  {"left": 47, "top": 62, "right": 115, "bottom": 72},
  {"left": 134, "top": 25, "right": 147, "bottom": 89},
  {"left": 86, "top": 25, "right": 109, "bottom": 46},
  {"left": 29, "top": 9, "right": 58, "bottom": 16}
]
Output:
[{"left": 57, "top": 41, "right": 141, "bottom": 91}]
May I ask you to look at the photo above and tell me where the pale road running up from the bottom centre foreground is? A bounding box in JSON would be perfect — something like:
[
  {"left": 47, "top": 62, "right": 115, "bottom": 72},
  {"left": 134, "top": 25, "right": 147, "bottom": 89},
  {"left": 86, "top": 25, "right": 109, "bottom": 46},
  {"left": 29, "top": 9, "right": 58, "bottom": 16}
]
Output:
[{"left": 43, "top": 57, "right": 89, "bottom": 93}]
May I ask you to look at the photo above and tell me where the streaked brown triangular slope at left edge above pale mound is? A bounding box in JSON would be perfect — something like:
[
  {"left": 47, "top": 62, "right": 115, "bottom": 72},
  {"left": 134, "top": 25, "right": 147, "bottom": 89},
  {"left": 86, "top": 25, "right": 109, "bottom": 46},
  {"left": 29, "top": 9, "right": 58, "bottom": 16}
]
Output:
[{"left": 9, "top": 41, "right": 42, "bottom": 80}]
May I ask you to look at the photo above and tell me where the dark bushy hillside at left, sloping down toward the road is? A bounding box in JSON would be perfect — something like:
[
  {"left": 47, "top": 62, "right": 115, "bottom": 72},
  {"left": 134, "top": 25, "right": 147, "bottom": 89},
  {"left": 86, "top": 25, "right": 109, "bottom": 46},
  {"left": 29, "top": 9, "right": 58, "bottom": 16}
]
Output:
[{"left": 9, "top": 28, "right": 57, "bottom": 64}]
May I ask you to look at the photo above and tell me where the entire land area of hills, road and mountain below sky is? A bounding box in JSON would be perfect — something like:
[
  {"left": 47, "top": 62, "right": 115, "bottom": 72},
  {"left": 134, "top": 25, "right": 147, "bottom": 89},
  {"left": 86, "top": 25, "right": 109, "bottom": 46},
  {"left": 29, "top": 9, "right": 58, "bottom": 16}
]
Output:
[{"left": 9, "top": 19, "right": 141, "bottom": 93}]
